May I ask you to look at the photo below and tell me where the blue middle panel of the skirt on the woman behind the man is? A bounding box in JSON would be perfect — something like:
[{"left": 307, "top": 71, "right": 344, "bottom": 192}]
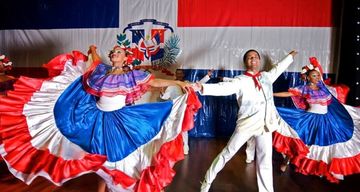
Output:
[{"left": 277, "top": 99, "right": 354, "bottom": 146}]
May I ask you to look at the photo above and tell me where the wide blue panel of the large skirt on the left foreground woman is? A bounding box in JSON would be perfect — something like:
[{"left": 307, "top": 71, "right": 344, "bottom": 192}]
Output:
[{"left": 54, "top": 78, "right": 172, "bottom": 162}]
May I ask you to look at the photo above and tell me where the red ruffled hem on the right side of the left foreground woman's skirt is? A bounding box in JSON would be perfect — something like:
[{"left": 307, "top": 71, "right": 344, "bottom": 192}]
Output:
[{"left": 103, "top": 91, "right": 201, "bottom": 192}]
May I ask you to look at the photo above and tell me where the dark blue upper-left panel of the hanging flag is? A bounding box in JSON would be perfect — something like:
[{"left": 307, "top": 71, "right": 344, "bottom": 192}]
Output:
[{"left": 0, "top": 0, "right": 119, "bottom": 30}]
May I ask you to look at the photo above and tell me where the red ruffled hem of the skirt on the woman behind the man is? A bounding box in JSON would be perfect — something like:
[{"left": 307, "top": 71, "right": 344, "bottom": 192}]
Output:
[{"left": 273, "top": 132, "right": 360, "bottom": 183}]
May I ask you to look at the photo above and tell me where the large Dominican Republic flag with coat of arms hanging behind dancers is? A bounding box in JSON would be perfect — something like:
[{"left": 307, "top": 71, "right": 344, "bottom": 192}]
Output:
[{"left": 0, "top": 0, "right": 339, "bottom": 73}]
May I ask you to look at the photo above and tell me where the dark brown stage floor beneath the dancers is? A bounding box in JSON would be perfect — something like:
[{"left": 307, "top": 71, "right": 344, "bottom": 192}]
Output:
[{"left": 0, "top": 138, "right": 360, "bottom": 192}]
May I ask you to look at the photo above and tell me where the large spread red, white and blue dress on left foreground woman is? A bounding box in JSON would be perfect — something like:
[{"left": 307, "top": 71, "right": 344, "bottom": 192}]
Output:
[{"left": 0, "top": 51, "right": 200, "bottom": 192}]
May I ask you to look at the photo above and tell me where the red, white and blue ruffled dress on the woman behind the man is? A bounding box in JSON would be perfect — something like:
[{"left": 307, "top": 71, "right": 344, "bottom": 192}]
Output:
[{"left": 273, "top": 82, "right": 360, "bottom": 182}]
